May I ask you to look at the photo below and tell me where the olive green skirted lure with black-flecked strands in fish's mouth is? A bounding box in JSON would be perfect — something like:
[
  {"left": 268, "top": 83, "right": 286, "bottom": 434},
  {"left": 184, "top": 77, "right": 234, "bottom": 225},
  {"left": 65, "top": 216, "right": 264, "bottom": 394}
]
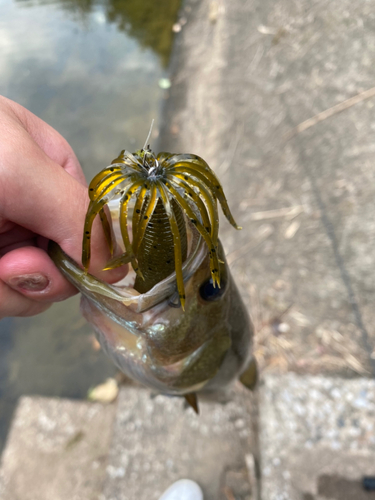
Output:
[{"left": 82, "top": 141, "right": 241, "bottom": 308}]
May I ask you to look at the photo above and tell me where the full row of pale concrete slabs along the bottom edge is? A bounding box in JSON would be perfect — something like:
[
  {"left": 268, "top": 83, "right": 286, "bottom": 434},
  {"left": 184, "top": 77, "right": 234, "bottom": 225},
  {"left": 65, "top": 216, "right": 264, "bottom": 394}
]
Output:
[{"left": 0, "top": 374, "right": 375, "bottom": 500}]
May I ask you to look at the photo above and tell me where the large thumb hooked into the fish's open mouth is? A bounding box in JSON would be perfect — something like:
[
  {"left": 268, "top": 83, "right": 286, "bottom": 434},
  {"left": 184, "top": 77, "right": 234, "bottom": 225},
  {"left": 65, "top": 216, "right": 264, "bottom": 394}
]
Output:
[{"left": 0, "top": 124, "right": 128, "bottom": 281}]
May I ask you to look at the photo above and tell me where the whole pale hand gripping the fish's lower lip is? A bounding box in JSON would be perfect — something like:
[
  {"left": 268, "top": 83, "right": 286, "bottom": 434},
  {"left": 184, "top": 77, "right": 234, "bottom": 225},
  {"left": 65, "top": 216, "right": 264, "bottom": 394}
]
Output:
[{"left": 0, "top": 96, "right": 126, "bottom": 319}]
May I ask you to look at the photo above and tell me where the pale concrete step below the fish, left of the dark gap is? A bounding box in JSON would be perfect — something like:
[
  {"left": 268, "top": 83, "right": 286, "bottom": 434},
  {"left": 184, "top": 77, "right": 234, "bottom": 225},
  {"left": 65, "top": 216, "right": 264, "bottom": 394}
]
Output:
[{"left": 0, "top": 386, "right": 258, "bottom": 500}]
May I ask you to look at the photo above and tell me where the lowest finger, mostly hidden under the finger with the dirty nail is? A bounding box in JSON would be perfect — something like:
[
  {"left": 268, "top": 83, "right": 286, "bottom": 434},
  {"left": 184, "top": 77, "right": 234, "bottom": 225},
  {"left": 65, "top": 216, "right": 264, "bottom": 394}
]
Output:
[{"left": 0, "top": 281, "right": 51, "bottom": 319}]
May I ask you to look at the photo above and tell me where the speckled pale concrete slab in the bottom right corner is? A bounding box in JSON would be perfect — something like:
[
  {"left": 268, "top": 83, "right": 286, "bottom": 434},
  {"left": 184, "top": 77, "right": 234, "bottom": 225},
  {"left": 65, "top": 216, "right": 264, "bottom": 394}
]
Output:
[{"left": 260, "top": 374, "right": 375, "bottom": 500}]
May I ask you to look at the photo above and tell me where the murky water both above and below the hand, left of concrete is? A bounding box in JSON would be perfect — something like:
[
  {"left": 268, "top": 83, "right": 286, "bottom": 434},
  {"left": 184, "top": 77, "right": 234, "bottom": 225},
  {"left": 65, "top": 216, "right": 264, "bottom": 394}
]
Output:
[{"left": 0, "top": 0, "right": 180, "bottom": 450}]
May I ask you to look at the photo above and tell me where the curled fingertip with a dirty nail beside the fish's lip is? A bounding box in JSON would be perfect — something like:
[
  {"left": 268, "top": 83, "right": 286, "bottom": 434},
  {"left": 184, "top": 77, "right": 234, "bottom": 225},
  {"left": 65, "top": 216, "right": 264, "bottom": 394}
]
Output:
[{"left": 0, "top": 247, "right": 77, "bottom": 302}]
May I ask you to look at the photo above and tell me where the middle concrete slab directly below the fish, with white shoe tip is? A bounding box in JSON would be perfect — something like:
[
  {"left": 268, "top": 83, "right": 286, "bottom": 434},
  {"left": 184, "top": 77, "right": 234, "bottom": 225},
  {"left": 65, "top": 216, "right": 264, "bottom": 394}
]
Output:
[{"left": 101, "top": 386, "right": 258, "bottom": 500}]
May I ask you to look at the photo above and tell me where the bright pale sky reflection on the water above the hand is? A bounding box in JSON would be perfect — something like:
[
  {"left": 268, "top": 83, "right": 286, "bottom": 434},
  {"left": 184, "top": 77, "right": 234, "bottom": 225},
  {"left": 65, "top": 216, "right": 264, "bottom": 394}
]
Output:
[{"left": 0, "top": 0, "right": 173, "bottom": 177}]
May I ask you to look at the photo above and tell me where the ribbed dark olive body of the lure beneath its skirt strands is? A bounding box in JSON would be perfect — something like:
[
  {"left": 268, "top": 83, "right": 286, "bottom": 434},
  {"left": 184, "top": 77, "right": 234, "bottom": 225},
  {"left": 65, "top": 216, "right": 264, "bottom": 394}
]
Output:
[{"left": 134, "top": 199, "right": 187, "bottom": 293}]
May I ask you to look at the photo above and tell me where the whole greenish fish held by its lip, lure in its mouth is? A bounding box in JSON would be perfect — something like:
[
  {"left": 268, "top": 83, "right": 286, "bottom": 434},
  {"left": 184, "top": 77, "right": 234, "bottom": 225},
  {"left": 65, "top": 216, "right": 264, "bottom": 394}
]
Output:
[{"left": 49, "top": 133, "right": 257, "bottom": 413}]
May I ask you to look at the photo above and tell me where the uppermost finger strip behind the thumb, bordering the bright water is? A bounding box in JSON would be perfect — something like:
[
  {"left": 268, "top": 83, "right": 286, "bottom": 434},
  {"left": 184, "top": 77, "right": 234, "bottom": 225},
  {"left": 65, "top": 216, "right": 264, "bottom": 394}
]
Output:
[{"left": 0, "top": 97, "right": 87, "bottom": 186}]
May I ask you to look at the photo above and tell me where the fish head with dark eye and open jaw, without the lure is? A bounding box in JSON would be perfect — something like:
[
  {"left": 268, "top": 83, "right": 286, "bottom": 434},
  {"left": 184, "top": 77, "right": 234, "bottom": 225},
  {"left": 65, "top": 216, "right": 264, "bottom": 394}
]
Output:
[{"left": 50, "top": 236, "right": 252, "bottom": 395}]
